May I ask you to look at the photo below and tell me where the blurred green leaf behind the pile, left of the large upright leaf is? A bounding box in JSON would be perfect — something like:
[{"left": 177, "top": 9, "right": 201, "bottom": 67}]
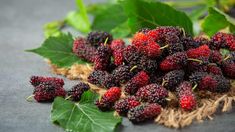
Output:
[{"left": 92, "top": 4, "right": 127, "bottom": 32}]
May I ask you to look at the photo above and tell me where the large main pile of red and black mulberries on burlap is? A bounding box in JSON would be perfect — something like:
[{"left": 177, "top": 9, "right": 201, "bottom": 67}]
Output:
[{"left": 70, "top": 26, "right": 235, "bottom": 123}]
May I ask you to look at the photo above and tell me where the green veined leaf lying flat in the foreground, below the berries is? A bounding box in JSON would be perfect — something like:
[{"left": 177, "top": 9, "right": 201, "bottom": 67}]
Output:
[{"left": 51, "top": 91, "right": 121, "bottom": 132}]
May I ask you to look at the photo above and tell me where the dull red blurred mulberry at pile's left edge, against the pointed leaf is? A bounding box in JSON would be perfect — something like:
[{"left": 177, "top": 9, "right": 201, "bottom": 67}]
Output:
[{"left": 73, "top": 38, "right": 96, "bottom": 62}]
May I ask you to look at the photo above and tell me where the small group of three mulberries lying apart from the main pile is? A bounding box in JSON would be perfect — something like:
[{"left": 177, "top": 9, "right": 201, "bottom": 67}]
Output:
[{"left": 29, "top": 76, "right": 90, "bottom": 102}]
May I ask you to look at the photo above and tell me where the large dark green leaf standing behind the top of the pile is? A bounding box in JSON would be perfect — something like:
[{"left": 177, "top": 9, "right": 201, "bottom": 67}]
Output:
[{"left": 121, "top": 0, "right": 193, "bottom": 34}]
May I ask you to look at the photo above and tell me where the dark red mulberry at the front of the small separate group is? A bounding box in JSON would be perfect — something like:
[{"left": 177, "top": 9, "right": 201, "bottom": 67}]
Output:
[{"left": 33, "top": 82, "right": 66, "bottom": 102}]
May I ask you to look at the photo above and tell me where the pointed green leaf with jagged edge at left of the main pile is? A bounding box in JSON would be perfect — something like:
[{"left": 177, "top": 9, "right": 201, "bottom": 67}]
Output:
[{"left": 27, "top": 34, "right": 86, "bottom": 67}]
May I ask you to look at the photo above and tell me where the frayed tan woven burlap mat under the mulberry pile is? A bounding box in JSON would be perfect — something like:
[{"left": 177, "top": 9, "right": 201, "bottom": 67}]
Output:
[{"left": 48, "top": 62, "right": 235, "bottom": 128}]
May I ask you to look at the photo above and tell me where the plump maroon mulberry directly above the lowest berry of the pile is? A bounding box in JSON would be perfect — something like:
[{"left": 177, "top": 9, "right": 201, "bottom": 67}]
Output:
[{"left": 136, "top": 84, "right": 168, "bottom": 107}]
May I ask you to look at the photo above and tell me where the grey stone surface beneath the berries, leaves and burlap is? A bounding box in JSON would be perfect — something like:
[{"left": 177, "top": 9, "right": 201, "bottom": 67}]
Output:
[{"left": 0, "top": 0, "right": 235, "bottom": 132}]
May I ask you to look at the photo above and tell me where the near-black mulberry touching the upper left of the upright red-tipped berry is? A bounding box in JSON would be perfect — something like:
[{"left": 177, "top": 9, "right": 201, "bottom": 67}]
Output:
[{"left": 162, "top": 70, "right": 185, "bottom": 91}]
